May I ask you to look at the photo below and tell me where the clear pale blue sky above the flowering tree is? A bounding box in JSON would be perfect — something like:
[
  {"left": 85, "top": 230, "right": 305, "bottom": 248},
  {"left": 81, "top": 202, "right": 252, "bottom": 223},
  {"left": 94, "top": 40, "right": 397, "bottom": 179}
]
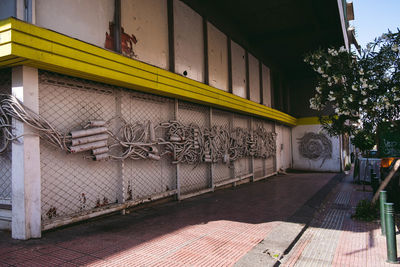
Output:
[{"left": 348, "top": 0, "right": 400, "bottom": 48}]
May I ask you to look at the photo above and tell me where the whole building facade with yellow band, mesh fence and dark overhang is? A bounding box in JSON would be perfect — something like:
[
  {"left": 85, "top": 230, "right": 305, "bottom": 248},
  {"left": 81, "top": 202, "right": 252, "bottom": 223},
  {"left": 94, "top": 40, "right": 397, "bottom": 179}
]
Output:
[{"left": 0, "top": 0, "right": 352, "bottom": 239}]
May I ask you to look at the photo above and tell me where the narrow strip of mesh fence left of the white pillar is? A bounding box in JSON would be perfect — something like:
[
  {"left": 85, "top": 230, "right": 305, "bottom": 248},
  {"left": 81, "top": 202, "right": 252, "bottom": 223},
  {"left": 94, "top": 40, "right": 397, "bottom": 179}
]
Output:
[{"left": 0, "top": 69, "right": 11, "bottom": 204}]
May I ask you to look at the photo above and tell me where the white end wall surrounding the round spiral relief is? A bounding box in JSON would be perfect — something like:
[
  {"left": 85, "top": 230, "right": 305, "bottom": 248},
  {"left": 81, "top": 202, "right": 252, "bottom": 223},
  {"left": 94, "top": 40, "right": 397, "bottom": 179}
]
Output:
[{"left": 292, "top": 125, "right": 341, "bottom": 172}]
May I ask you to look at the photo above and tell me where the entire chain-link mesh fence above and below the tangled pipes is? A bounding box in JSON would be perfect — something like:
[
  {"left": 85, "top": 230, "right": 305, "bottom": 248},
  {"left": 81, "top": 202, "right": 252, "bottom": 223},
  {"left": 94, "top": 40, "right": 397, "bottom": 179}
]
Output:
[{"left": 28, "top": 71, "right": 275, "bottom": 228}]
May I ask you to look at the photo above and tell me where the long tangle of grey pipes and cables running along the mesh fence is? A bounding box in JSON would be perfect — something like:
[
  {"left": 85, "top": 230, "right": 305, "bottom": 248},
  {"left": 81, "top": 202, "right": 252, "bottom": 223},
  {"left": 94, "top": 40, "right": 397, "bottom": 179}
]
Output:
[{"left": 0, "top": 95, "right": 276, "bottom": 165}]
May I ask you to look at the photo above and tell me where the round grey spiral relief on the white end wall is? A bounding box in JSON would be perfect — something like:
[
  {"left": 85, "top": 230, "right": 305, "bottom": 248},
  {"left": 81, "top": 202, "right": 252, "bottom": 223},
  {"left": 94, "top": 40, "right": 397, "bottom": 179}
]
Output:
[{"left": 298, "top": 132, "right": 332, "bottom": 167}]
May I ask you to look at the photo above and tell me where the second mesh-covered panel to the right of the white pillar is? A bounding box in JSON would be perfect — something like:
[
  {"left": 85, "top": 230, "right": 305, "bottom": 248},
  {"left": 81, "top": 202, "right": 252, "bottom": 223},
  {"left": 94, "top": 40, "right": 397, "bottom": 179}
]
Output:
[{"left": 121, "top": 90, "right": 176, "bottom": 201}]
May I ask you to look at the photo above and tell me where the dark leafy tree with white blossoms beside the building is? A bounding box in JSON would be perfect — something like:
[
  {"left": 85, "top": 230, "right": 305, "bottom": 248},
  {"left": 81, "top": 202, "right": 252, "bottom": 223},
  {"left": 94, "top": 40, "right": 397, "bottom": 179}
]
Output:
[{"left": 304, "top": 29, "right": 400, "bottom": 135}]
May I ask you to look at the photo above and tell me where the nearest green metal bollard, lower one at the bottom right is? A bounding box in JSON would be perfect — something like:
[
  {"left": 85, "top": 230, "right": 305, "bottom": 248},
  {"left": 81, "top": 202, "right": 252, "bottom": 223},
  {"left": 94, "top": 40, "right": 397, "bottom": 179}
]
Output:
[{"left": 385, "top": 203, "right": 398, "bottom": 263}]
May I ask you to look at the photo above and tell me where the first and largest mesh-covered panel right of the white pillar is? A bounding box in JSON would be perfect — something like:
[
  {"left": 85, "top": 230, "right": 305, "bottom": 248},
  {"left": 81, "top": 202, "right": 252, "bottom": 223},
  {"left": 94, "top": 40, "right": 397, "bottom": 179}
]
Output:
[{"left": 39, "top": 72, "right": 121, "bottom": 224}]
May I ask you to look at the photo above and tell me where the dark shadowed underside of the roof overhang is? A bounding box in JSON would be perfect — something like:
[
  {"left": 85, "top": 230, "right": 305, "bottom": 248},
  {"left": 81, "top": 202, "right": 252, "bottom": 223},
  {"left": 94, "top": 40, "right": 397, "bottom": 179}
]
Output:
[{"left": 183, "top": 0, "right": 344, "bottom": 75}]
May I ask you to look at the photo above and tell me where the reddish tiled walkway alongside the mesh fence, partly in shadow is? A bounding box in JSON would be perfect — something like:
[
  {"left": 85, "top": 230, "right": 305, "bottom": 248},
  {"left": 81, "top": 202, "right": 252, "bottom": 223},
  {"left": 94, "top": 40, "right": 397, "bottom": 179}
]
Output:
[{"left": 0, "top": 173, "right": 335, "bottom": 266}]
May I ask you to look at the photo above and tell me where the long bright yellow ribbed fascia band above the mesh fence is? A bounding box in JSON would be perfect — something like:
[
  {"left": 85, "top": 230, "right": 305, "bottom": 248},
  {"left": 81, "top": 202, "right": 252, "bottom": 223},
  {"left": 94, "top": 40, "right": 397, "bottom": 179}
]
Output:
[{"left": 0, "top": 18, "right": 297, "bottom": 126}]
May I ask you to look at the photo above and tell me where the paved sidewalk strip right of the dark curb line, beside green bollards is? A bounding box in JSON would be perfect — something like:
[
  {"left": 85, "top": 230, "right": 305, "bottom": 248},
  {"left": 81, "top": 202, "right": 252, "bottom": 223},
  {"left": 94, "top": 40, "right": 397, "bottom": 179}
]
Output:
[{"left": 282, "top": 176, "right": 400, "bottom": 267}]
